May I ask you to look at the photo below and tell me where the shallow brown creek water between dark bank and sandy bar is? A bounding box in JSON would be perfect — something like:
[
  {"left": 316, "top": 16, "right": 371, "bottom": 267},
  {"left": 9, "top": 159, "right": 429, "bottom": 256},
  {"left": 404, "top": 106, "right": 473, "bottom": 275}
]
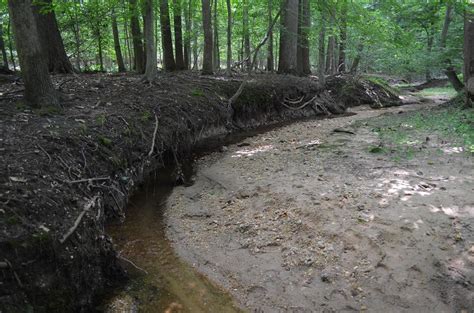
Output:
[{"left": 104, "top": 169, "right": 241, "bottom": 313}]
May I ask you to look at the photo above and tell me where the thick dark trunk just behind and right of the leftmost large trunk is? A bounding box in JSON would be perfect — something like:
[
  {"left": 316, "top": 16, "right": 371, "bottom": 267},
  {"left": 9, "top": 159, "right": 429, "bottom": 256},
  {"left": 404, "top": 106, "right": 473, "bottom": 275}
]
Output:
[{"left": 33, "top": 0, "right": 74, "bottom": 73}]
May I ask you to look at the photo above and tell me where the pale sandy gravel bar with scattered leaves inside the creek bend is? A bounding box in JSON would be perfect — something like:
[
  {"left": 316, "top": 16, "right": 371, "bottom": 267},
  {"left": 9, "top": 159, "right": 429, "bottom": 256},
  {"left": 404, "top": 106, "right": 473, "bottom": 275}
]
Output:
[{"left": 165, "top": 97, "right": 474, "bottom": 312}]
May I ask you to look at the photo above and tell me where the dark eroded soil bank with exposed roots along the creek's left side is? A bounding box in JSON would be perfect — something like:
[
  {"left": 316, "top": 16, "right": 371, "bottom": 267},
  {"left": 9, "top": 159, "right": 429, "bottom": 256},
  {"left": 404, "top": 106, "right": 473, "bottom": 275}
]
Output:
[{"left": 0, "top": 73, "right": 399, "bottom": 312}]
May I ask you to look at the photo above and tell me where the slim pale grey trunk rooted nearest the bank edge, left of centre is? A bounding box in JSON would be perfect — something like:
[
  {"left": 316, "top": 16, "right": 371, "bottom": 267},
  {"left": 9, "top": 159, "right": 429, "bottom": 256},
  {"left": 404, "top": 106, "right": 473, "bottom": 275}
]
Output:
[{"left": 143, "top": 0, "right": 157, "bottom": 82}]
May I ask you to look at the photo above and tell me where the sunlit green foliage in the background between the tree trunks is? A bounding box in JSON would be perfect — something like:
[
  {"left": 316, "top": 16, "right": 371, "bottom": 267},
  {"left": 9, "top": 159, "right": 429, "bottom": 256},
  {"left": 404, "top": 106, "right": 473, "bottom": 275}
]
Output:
[{"left": 0, "top": 0, "right": 466, "bottom": 80}]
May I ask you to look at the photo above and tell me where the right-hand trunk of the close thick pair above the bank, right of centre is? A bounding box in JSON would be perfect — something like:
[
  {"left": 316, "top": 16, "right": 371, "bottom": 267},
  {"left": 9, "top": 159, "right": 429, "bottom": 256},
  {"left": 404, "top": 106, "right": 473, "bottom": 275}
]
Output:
[{"left": 297, "top": 0, "right": 311, "bottom": 75}]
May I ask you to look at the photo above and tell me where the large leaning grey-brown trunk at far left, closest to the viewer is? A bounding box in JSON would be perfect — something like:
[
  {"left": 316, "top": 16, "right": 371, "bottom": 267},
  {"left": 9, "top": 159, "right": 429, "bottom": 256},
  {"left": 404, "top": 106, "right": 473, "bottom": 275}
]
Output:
[{"left": 8, "top": 0, "right": 59, "bottom": 107}]
